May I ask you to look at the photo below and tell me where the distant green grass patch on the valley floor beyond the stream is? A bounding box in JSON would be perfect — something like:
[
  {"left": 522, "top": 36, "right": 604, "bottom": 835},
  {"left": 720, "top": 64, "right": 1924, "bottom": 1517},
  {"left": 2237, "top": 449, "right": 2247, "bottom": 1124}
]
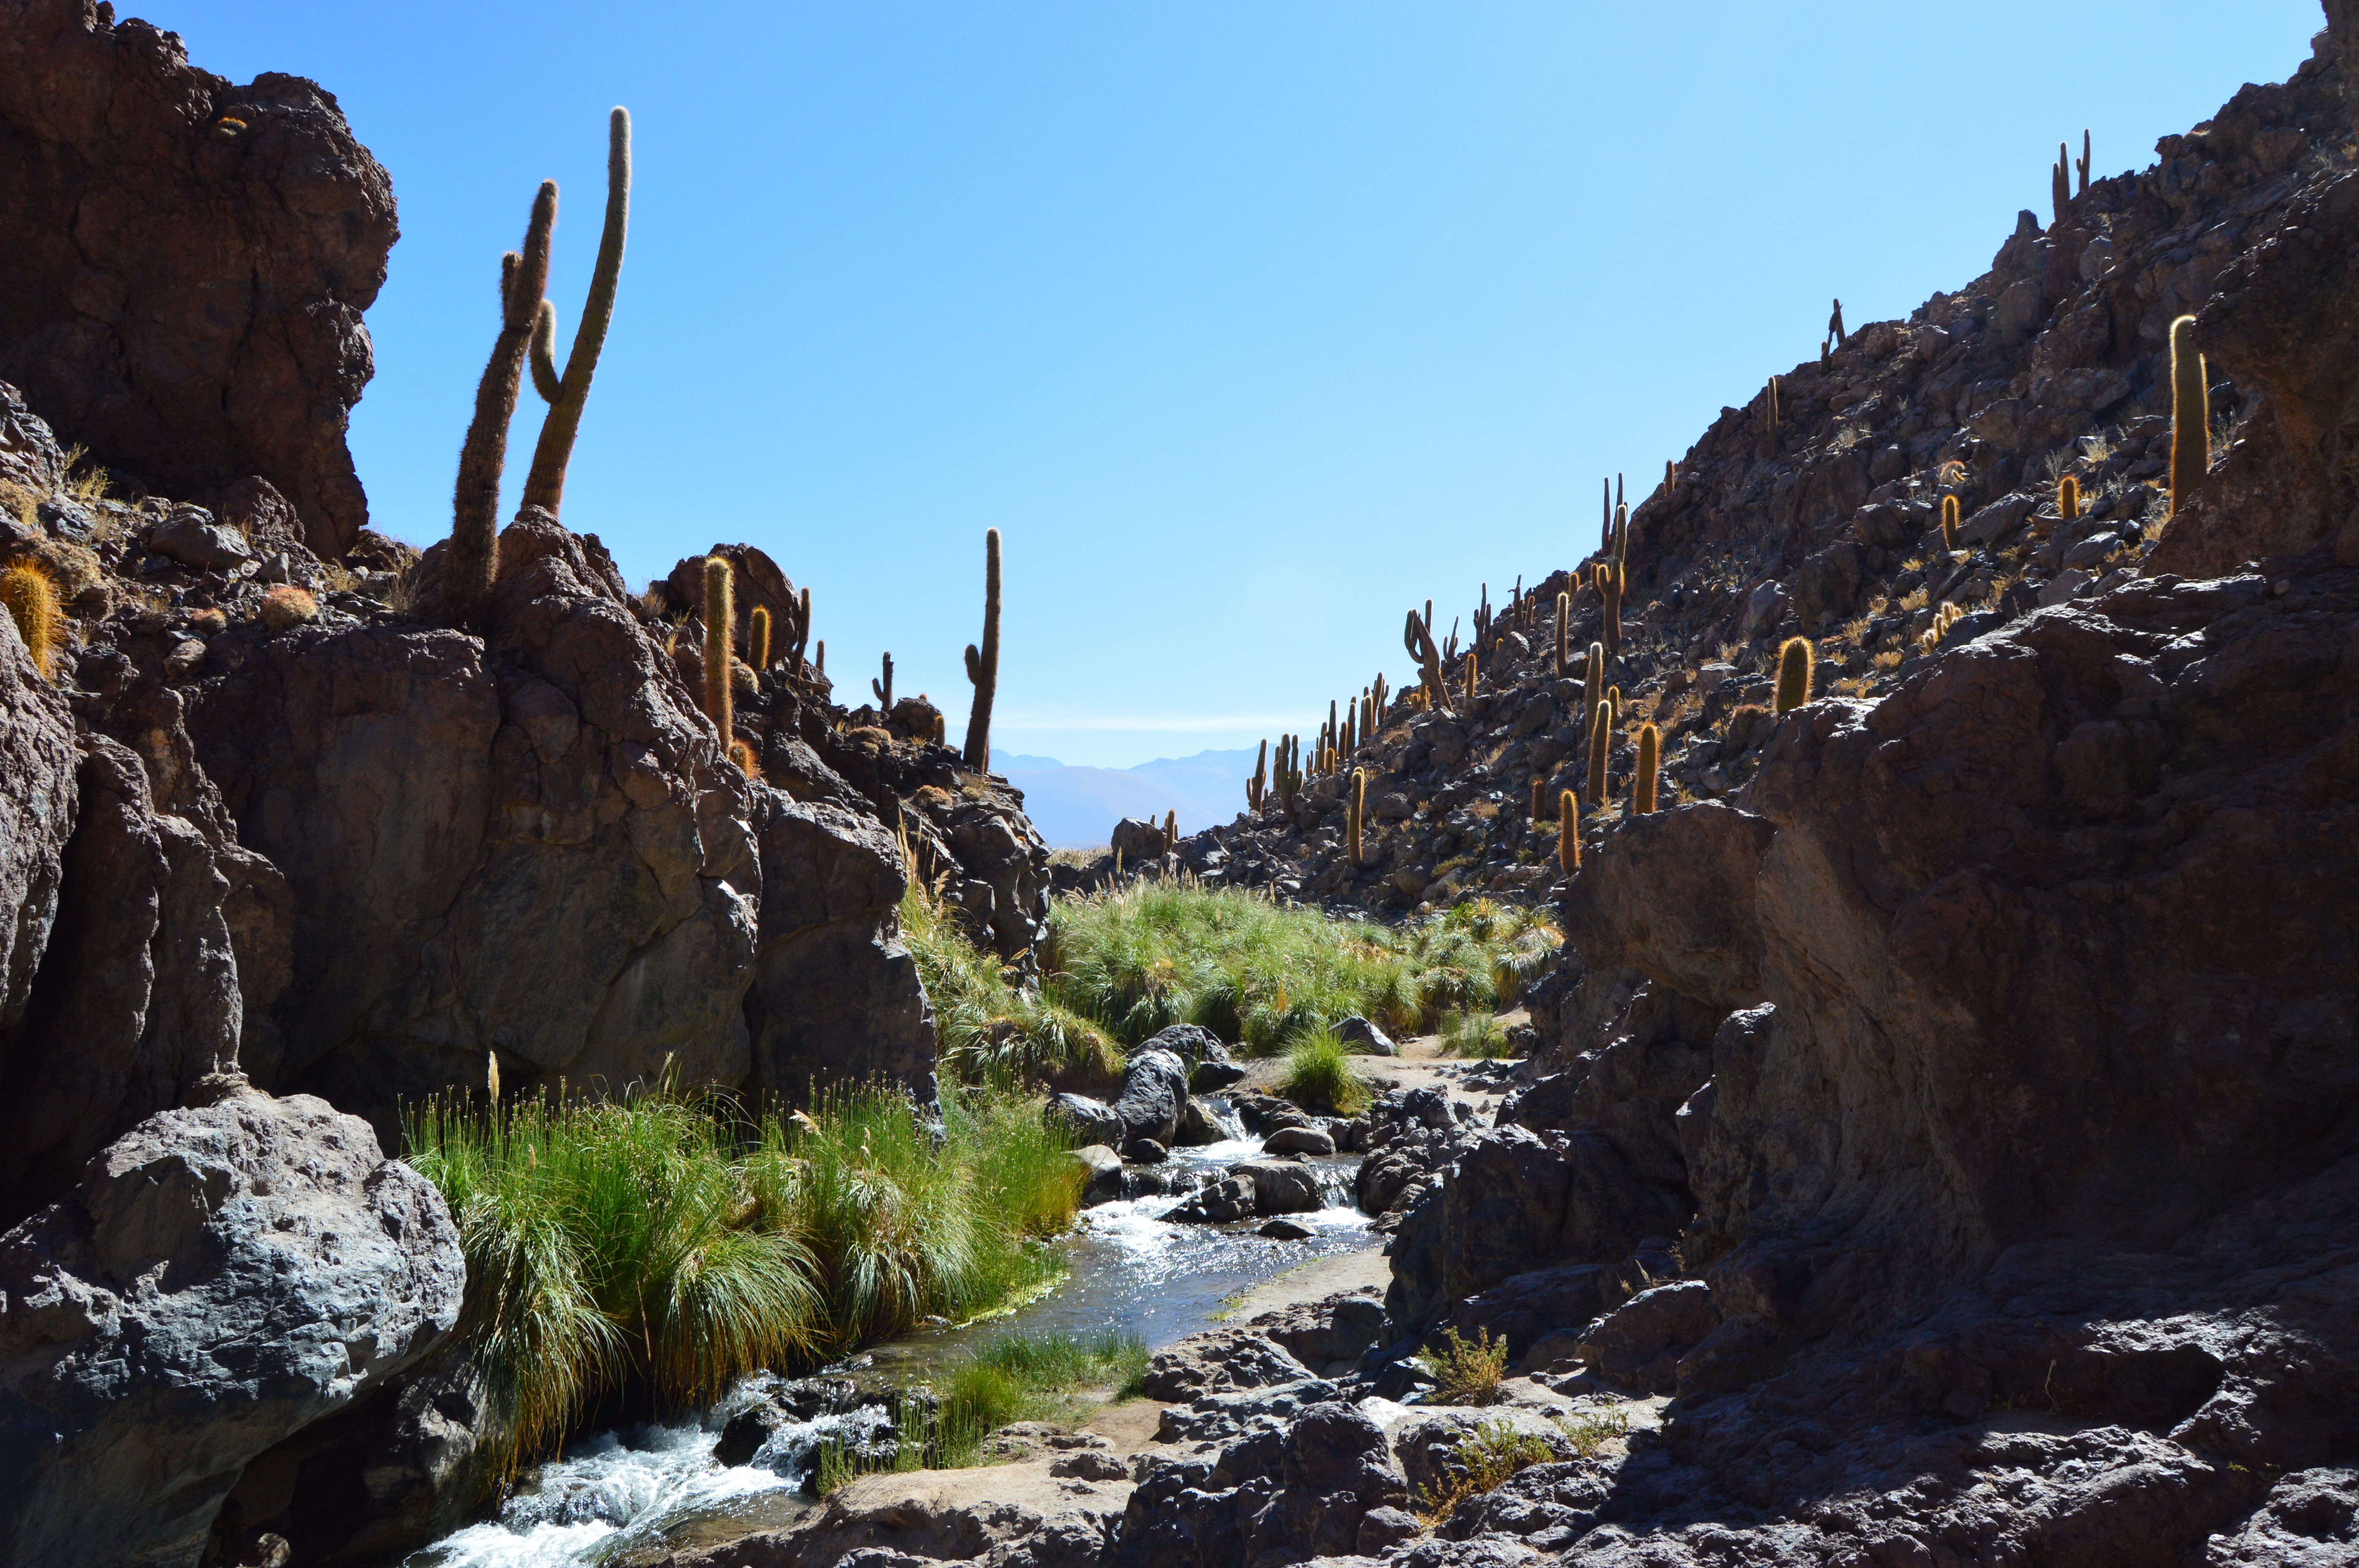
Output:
[{"left": 1043, "top": 880, "right": 1562, "bottom": 1054}]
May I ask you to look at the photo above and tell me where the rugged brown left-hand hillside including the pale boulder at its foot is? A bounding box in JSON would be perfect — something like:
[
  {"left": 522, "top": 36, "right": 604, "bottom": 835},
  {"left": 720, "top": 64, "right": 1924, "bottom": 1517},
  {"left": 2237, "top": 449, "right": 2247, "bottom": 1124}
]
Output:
[{"left": 0, "top": 0, "right": 1047, "bottom": 1563}]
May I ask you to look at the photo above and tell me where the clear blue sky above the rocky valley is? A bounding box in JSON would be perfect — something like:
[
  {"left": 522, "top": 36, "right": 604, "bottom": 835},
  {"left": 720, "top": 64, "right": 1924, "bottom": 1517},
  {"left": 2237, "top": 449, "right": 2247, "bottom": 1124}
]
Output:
[{"left": 171, "top": 0, "right": 2321, "bottom": 766}]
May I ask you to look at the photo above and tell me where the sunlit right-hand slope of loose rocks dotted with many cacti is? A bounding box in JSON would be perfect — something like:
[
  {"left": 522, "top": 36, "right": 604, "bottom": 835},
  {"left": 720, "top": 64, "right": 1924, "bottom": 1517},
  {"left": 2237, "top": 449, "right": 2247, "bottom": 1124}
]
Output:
[{"left": 1180, "top": 21, "right": 2359, "bottom": 910}]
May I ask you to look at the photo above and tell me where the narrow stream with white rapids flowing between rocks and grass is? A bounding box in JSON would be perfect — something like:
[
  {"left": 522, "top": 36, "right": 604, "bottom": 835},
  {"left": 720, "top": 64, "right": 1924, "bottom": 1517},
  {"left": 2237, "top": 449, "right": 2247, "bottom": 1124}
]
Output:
[{"left": 403, "top": 1099, "right": 1380, "bottom": 1568}]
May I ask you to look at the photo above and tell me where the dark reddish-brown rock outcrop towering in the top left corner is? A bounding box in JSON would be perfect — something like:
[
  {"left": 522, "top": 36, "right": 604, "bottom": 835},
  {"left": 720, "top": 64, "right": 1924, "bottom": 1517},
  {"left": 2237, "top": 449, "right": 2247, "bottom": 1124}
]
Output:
[{"left": 0, "top": 0, "right": 396, "bottom": 559}]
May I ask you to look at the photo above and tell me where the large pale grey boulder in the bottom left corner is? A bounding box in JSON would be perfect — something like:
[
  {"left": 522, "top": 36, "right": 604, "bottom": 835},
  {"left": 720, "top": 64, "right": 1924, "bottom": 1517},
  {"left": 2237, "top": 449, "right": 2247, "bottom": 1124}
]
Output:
[{"left": 0, "top": 1089, "right": 465, "bottom": 1568}]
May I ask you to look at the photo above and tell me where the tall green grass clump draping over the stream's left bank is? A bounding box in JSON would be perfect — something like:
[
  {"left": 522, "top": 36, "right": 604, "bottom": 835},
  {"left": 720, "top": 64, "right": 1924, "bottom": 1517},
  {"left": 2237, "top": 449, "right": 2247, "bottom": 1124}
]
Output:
[{"left": 406, "top": 1087, "right": 1080, "bottom": 1481}]
